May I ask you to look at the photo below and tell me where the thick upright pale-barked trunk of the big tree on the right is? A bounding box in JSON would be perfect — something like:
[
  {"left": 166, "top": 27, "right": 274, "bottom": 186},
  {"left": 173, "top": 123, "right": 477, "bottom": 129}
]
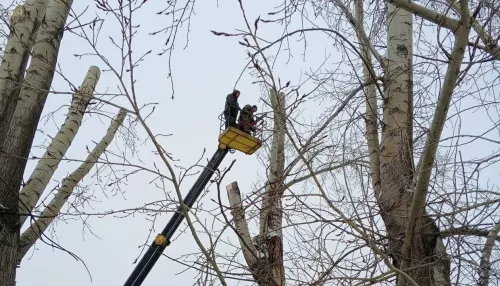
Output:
[{"left": 378, "top": 1, "right": 414, "bottom": 280}]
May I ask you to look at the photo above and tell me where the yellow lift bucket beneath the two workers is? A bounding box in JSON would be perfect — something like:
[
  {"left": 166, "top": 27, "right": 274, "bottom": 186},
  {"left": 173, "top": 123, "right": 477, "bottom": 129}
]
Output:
[{"left": 219, "top": 127, "right": 262, "bottom": 155}]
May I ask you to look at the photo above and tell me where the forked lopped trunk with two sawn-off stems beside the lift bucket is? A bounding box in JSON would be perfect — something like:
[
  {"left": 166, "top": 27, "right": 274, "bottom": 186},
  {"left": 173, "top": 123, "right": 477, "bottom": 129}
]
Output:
[{"left": 226, "top": 88, "right": 286, "bottom": 286}]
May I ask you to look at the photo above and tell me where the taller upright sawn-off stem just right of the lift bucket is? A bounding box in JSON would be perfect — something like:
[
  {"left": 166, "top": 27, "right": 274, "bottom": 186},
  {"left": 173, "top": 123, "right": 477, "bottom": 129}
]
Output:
[{"left": 258, "top": 89, "right": 285, "bottom": 286}]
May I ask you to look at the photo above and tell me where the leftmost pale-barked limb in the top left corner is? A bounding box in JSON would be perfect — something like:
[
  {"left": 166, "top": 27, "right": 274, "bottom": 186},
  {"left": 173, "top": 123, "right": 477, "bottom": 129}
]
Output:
[{"left": 0, "top": 0, "right": 49, "bottom": 146}]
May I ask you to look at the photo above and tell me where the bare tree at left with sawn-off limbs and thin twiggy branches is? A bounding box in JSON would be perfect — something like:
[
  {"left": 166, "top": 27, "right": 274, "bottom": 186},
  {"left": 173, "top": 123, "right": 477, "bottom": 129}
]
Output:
[{"left": 0, "top": 0, "right": 224, "bottom": 286}]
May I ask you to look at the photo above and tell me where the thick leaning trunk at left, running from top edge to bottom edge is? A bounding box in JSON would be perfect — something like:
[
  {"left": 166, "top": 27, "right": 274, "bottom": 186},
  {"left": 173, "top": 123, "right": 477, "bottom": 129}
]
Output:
[{"left": 0, "top": 0, "right": 72, "bottom": 286}]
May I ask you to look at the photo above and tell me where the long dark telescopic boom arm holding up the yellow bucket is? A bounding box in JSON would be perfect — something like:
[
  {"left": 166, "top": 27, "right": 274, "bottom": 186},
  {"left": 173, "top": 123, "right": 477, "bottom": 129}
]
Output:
[{"left": 124, "top": 148, "right": 229, "bottom": 286}]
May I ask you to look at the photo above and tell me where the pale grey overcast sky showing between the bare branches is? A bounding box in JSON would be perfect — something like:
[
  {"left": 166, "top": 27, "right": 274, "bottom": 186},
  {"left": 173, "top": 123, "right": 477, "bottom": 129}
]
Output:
[{"left": 11, "top": 0, "right": 499, "bottom": 286}]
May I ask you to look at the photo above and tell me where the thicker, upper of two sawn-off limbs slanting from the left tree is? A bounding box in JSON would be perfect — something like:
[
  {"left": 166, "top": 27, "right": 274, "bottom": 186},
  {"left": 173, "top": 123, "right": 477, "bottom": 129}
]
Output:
[{"left": 19, "top": 66, "right": 101, "bottom": 225}]
